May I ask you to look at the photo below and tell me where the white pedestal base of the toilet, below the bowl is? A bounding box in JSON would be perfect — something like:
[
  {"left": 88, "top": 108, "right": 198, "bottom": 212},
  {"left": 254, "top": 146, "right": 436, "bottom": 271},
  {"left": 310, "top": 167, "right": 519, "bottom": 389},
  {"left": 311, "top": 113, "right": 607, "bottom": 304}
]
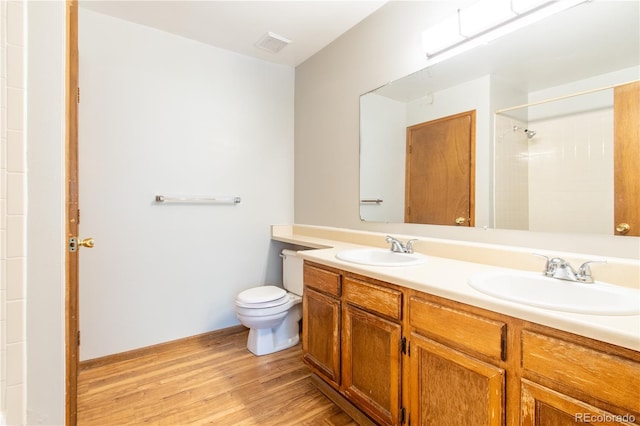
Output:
[{"left": 247, "top": 304, "right": 302, "bottom": 356}]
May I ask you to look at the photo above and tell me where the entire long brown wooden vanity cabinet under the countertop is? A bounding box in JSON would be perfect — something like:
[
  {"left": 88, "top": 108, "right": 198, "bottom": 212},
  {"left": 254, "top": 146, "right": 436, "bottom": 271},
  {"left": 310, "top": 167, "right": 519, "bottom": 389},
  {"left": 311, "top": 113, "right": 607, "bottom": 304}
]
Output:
[{"left": 303, "top": 261, "right": 640, "bottom": 426}]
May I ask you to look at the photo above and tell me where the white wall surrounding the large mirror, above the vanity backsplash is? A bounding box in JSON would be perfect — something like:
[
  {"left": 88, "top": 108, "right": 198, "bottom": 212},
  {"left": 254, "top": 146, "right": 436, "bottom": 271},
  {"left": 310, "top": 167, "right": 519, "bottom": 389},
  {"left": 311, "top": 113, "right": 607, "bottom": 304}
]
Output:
[{"left": 295, "top": 1, "right": 640, "bottom": 258}]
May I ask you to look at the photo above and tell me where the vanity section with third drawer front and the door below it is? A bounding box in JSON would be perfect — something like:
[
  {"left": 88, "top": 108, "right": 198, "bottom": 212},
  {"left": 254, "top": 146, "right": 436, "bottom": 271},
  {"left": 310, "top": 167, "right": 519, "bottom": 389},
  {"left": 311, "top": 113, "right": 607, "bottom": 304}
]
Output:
[{"left": 408, "top": 293, "right": 507, "bottom": 426}]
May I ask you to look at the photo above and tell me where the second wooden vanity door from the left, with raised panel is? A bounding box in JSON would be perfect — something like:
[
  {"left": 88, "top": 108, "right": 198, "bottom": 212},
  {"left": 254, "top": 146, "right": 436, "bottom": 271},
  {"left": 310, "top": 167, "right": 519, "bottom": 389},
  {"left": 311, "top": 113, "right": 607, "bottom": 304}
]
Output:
[{"left": 342, "top": 303, "right": 402, "bottom": 425}]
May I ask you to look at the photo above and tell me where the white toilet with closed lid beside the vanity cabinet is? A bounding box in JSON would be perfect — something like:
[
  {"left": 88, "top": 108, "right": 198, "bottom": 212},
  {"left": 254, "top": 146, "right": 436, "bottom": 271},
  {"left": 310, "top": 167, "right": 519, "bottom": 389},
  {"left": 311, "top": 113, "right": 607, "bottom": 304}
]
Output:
[{"left": 236, "top": 250, "right": 303, "bottom": 355}]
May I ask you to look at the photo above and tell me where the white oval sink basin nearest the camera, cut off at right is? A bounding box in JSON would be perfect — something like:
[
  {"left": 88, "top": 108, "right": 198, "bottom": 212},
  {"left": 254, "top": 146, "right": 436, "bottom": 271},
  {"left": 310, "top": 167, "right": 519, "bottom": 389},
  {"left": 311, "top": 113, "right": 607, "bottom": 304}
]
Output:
[{"left": 469, "top": 271, "right": 640, "bottom": 315}]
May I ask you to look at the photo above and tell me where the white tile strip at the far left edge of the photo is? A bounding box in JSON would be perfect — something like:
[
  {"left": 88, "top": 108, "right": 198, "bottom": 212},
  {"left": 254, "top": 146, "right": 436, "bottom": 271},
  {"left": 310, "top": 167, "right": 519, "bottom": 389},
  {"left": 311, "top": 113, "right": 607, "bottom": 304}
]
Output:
[{"left": 0, "top": 1, "right": 26, "bottom": 424}]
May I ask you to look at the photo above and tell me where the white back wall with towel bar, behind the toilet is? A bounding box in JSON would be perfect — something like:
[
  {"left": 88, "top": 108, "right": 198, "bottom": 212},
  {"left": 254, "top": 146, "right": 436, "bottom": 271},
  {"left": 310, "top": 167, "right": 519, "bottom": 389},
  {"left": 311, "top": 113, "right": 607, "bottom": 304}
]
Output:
[{"left": 79, "top": 9, "right": 294, "bottom": 360}]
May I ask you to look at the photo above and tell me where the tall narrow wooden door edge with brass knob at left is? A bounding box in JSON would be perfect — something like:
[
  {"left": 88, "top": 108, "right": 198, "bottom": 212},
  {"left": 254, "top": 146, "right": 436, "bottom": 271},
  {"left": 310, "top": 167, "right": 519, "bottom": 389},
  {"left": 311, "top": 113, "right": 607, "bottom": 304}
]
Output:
[{"left": 63, "top": 0, "right": 79, "bottom": 426}]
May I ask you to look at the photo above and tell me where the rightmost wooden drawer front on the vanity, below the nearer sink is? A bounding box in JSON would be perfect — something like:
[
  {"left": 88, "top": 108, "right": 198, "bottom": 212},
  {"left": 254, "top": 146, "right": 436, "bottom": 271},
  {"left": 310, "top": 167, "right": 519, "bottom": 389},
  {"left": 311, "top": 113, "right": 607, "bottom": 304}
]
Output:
[{"left": 522, "top": 330, "right": 640, "bottom": 413}]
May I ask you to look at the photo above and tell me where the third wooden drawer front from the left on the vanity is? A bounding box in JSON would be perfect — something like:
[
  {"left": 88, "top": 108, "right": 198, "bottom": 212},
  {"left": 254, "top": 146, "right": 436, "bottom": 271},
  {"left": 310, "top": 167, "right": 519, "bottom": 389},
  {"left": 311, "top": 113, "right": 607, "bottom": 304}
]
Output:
[{"left": 409, "top": 296, "right": 507, "bottom": 361}]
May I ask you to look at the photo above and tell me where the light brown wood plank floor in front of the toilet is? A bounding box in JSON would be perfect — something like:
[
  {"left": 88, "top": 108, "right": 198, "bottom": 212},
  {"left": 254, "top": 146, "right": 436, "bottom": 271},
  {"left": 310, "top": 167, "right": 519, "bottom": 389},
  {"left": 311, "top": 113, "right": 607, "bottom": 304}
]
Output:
[{"left": 78, "top": 331, "right": 357, "bottom": 426}]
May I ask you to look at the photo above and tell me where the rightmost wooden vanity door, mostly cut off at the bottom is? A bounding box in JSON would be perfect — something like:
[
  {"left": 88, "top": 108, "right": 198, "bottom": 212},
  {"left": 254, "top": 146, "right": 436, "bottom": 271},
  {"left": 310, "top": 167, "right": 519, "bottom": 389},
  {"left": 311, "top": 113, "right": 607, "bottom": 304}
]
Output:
[{"left": 520, "top": 379, "right": 638, "bottom": 426}]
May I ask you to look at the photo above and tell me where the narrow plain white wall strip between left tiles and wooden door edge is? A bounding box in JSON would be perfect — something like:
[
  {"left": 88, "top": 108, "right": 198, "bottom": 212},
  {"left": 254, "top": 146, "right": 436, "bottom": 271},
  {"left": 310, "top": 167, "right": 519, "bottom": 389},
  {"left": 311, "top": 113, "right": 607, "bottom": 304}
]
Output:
[{"left": 24, "top": 1, "right": 65, "bottom": 425}]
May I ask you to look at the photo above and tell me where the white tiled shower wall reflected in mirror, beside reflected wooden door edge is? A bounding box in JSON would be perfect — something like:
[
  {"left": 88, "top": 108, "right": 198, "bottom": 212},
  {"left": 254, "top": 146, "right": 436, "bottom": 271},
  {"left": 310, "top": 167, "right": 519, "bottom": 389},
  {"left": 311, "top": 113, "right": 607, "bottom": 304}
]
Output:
[{"left": 529, "top": 108, "right": 614, "bottom": 234}]
